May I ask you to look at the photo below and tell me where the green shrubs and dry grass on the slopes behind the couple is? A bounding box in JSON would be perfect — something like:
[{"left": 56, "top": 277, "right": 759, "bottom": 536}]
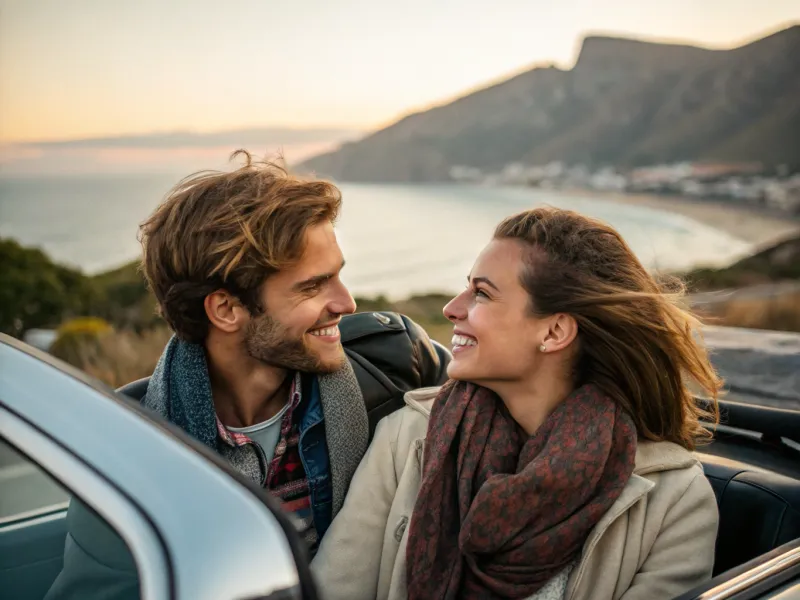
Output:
[{"left": 0, "top": 232, "right": 800, "bottom": 387}]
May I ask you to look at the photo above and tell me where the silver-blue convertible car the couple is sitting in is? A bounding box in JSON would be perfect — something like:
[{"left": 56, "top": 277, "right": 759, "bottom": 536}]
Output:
[{"left": 0, "top": 328, "right": 800, "bottom": 600}]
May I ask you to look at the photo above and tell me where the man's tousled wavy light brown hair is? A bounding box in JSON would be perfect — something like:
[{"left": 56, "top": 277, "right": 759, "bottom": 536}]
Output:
[{"left": 139, "top": 150, "right": 342, "bottom": 343}]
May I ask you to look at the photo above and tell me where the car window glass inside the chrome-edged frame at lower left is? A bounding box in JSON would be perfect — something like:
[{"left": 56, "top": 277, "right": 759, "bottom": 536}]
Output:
[{"left": 0, "top": 438, "right": 139, "bottom": 600}]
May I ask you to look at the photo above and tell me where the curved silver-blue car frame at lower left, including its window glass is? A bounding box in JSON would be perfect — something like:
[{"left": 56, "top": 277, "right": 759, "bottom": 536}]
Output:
[{"left": 0, "top": 336, "right": 316, "bottom": 600}]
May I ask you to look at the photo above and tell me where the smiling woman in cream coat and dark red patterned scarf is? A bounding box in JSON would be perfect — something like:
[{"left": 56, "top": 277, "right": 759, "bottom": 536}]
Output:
[{"left": 312, "top": 208, "right": 721, "bottom": 600}]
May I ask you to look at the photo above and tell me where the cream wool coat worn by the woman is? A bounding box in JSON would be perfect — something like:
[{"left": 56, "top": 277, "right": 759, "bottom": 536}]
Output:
[{"left": 311, "top": 388, "right": 719, "bottom": 600}]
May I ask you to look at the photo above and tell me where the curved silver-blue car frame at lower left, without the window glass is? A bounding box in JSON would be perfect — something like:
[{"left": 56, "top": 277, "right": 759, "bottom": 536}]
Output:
[{"left": 0, "top": 334, "right": 317, "bottom": 600}]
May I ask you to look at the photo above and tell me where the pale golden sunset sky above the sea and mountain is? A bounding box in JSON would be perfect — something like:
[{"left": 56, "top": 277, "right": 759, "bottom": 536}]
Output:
[{"left": 0, "top": 0, "right": 800, "bottom": 172}]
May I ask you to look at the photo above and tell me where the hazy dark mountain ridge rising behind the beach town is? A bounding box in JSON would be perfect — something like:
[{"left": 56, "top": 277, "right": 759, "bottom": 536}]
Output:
[{"left": 298, "top": 25, "right": 800, "bottom": 181}]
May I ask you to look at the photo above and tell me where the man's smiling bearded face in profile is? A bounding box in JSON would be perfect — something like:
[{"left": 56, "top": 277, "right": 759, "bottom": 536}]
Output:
[{"left": 244, "top": 222, "right": 356, "bottom": 373}]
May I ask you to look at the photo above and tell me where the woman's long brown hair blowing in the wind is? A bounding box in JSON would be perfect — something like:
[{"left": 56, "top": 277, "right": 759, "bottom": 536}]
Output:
[{"left": 494, "top": 207, "right": 722, "bottom": 450}]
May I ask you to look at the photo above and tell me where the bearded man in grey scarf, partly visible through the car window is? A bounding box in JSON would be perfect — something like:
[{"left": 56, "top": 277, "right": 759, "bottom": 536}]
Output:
[{"left": 47, "top": 151, "right": 446, "bottom": 600}]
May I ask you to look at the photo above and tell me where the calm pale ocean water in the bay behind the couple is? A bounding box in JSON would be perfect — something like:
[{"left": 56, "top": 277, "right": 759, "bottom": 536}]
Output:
[{"left": 0, "top": 175, "right": 750, "bottom": 298}]
